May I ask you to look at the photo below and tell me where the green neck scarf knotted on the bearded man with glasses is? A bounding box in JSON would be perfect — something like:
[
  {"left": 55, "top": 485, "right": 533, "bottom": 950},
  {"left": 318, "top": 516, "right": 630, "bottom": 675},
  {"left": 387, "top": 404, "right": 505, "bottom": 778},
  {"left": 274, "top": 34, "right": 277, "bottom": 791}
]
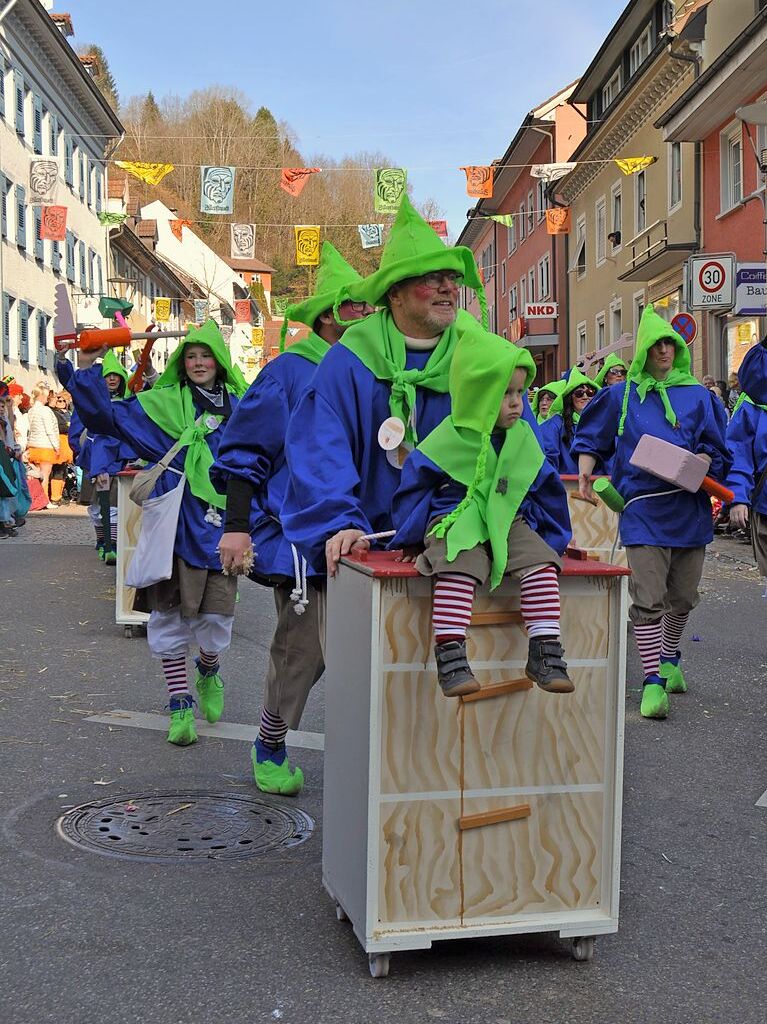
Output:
[{"left": 339, "top": 309, "right": 458, "bottom": 444}]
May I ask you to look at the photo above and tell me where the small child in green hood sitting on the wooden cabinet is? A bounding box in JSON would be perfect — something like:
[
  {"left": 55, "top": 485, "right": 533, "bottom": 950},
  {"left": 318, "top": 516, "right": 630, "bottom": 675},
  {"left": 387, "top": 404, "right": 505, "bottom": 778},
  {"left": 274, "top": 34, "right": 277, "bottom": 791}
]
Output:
[{"left": 390, "top": 324, "right": 573, "bottom": 696}]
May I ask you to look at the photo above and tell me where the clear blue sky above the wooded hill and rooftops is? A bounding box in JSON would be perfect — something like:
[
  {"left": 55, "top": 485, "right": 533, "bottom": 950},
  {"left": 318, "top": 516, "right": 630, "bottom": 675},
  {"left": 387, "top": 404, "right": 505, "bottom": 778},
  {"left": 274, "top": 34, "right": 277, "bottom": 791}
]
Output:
[{"left": 67, "top": 0, "right": 626, "bottom": 237}]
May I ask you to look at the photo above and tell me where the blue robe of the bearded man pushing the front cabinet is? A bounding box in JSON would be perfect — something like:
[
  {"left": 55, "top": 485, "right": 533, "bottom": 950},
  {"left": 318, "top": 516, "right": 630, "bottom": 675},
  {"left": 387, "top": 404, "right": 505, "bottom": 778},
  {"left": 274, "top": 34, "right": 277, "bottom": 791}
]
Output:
[{"left": 283, "top": 344, "right": 450, "bottom": 565}]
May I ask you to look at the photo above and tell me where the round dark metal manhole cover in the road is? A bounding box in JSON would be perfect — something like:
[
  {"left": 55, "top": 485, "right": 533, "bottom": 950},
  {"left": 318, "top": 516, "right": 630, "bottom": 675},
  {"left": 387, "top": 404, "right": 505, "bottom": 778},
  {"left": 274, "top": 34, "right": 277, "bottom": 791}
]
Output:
[{"left": 56, "top": 793, "right": 314, "bottom": 863}]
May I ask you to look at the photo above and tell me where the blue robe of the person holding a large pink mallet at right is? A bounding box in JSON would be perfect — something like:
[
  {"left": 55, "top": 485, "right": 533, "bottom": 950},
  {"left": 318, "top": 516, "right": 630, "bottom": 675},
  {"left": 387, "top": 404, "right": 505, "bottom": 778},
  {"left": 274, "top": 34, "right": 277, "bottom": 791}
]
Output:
[{"left": 571, "top": 382, "right": 730, "bottom": 548}]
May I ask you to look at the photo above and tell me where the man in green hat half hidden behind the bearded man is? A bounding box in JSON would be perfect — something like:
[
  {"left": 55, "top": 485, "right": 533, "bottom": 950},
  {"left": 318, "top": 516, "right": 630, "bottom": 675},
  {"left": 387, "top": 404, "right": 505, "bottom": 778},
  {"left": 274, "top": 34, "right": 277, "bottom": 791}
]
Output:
[{"left": 211, "top": 242, "right": 374, "bottom": 796}]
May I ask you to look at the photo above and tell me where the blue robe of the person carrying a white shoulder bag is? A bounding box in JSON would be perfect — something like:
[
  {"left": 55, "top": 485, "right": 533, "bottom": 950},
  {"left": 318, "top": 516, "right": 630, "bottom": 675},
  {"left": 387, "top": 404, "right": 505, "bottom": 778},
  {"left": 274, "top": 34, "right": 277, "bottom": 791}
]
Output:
[{"left": 57, "top": 362, "right": 238, "bottom": 572}]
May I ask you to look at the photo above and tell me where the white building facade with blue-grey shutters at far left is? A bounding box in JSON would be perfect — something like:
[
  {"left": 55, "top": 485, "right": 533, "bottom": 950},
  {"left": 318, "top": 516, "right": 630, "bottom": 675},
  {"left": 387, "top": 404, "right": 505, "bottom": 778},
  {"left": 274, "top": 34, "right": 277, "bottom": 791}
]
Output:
[{"left": 0, "top": 0, "right": 123, "bottom": 387}]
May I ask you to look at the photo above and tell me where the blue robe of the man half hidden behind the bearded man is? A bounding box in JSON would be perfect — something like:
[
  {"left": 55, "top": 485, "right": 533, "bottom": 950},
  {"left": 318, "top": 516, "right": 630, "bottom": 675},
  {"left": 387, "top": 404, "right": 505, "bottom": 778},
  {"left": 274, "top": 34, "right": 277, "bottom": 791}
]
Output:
[{"left": 211, "top": 351, "right": 324, "bottom": 578}]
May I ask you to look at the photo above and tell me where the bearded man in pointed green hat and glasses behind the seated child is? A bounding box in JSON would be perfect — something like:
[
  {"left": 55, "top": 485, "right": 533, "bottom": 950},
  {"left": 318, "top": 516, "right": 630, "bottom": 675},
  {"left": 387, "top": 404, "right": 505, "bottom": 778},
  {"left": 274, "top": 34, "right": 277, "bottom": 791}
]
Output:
[{"left": 283, "top": 196, "right": 486, "bottom": 602}]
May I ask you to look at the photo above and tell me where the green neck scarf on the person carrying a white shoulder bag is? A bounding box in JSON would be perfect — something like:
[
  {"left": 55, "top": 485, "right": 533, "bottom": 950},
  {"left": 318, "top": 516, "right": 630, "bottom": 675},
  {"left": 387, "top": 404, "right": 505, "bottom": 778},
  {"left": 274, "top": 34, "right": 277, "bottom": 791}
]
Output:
[{"left": 136, "top": 384, "right": 233, "bottom": 509}]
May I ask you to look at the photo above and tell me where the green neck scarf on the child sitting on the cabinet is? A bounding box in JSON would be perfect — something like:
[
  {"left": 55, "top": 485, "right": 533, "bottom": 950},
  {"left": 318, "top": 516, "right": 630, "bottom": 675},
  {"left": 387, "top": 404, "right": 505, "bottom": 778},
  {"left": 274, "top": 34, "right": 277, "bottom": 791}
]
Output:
[{"left": 418, "top": 417, "right": 545, "bottom": 590}]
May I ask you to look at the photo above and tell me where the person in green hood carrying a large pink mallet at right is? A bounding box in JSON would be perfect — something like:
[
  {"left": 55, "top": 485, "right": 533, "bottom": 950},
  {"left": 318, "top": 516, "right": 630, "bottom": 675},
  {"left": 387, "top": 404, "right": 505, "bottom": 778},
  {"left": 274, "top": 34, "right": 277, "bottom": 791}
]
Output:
[{"left": 572, "top": 305, "right": 730, "bottom": 718}]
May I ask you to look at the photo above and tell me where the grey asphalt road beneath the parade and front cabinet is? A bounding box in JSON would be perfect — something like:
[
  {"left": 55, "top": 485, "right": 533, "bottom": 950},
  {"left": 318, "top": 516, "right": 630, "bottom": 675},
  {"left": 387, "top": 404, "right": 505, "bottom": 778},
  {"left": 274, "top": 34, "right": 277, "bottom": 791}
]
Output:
[{"left": 0, "top": 513, "right": 767, "bottom": 1024}]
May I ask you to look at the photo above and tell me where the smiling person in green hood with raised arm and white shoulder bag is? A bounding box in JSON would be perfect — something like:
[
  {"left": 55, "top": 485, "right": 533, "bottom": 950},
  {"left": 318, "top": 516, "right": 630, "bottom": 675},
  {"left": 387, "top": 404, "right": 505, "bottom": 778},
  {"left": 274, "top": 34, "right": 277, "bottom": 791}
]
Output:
[{"left": 58, "top": 321, "right": 247, "bottom": 746}]
